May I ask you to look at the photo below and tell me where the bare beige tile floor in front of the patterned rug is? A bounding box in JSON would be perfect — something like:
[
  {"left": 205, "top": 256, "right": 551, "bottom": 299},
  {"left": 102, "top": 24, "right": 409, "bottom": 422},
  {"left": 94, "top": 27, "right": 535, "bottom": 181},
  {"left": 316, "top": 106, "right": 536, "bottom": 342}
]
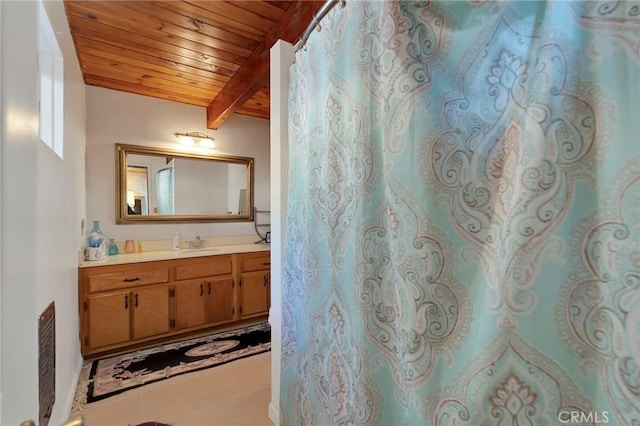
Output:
[{"left": 71, "top": 352, "right": 272, "bottom": 426}]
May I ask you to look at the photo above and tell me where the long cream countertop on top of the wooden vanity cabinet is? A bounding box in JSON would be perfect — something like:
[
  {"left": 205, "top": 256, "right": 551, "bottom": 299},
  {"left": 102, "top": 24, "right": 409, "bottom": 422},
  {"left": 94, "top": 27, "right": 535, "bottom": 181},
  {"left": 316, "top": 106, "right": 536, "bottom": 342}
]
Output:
[{"left": 78, "top": 243, "right": 271, "bottom": 268}]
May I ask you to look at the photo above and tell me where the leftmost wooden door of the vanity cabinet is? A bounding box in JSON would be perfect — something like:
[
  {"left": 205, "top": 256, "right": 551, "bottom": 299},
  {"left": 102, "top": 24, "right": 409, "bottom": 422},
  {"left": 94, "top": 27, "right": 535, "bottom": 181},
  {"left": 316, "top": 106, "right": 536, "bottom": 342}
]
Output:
[{"left": 87, "top": 290, "right": 131, "bottom": 350}]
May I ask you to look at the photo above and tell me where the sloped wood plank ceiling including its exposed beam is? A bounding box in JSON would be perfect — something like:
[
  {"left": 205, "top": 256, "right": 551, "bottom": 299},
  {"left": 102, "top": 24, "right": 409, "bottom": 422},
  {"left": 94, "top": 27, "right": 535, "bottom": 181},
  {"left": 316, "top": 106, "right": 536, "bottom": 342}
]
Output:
[{"left": 65, "top": 0, "right": 324, "bottom": 129}]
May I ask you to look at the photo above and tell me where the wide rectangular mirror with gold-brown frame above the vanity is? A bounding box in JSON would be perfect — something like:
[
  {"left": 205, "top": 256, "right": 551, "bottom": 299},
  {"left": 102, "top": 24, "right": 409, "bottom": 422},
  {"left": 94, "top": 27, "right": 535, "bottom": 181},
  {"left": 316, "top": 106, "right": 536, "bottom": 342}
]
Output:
[{"left": 116, "top": 144, "right": 254, "bottom": 224}]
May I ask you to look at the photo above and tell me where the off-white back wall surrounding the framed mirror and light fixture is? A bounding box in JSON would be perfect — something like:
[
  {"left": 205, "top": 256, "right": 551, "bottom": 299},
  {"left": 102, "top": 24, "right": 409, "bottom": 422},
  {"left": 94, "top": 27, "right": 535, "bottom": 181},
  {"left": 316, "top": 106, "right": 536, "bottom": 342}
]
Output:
[{"left": 87, "top": 87, "right": 270, "bottom": 241}]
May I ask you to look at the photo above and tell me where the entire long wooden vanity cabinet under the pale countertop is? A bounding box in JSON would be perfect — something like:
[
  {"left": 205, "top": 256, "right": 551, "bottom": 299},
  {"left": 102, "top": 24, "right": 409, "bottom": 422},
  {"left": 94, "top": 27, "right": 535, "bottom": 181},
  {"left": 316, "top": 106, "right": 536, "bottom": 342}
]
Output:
[{"left": 78, "top": 252, "right": 270, "bottom": 357}]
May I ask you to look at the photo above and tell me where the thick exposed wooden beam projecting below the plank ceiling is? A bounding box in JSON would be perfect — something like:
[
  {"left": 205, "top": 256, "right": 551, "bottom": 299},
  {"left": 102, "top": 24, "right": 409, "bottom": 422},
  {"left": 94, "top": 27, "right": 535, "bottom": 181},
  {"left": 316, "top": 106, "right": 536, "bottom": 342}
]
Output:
[{"left": 207, "top": 1, "right": 324, "bottom": 130}]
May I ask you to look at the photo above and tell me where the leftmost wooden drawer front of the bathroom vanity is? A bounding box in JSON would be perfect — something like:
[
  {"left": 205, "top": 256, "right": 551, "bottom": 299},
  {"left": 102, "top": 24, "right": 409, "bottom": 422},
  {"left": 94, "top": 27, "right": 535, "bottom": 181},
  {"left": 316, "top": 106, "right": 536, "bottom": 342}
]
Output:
[{"left": 87, "top": 266, "right": 169, "bottom": 293}]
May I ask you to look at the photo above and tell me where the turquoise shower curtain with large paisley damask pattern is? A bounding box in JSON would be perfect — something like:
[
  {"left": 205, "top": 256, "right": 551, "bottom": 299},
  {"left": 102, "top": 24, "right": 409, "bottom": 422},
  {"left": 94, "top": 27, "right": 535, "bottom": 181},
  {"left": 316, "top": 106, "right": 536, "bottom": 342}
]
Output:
[{"left": 280, "top": 0, "right": 640, "bottom": 426}]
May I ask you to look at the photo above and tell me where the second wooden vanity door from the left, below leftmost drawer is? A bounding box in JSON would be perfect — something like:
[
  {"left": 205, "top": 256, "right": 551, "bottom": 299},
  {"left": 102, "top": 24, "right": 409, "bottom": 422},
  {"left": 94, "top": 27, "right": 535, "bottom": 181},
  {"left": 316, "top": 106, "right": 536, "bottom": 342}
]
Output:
[{"left": 131, "top": 284, "right": 170, "bottom": 339}]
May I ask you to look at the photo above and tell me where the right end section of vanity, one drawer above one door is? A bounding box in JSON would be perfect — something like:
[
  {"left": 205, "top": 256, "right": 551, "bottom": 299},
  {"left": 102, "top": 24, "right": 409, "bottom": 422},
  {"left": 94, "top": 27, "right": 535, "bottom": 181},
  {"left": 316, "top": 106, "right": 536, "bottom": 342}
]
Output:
[{"left": 238, "top": 252, "right": 271, "bottom": 318}]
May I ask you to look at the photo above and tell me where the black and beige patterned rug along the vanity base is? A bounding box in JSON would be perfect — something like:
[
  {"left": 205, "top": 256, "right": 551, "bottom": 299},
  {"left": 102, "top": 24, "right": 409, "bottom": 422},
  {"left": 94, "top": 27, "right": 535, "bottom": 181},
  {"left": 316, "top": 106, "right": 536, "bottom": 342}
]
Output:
[{"left": 74, "top": 322, "right": 271, "bottom": 408}]
